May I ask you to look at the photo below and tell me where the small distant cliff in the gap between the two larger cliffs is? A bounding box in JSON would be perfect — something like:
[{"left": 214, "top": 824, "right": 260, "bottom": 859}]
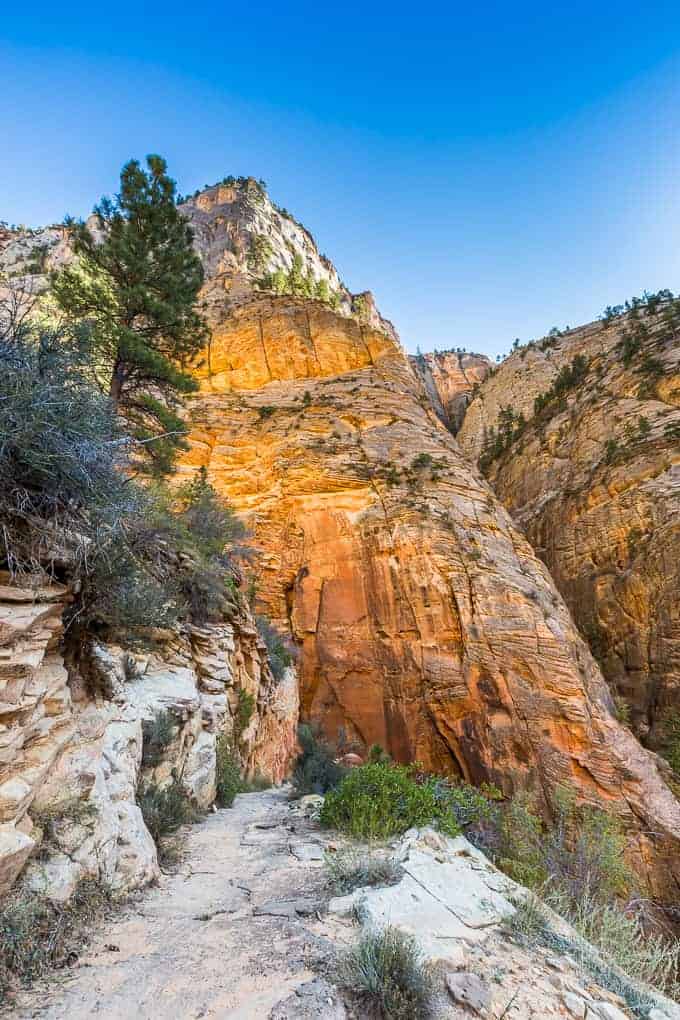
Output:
[{"left": 411, "top": 351, "right": 491, "bottom": 435}]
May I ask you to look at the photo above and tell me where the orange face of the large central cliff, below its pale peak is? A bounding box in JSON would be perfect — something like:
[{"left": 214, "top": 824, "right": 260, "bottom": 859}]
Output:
[{"left": 181, "top": 298, "right": 680, "bottom": 893}]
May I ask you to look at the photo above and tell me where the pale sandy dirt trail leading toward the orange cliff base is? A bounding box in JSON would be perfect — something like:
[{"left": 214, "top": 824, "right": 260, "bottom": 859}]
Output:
[{"left": 10, "top": 789, "right": 346, "bottom": 1020}]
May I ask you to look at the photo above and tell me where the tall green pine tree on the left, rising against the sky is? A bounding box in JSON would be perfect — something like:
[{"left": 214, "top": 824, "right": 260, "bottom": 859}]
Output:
[{"left": 52, "top": 156, "right": 207, "bottom": 474}]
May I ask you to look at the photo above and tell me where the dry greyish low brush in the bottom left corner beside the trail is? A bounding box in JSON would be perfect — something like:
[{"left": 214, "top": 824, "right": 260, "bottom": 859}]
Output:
[{"left": 0, "top": 880, "right": 110, "bottom": 1006}]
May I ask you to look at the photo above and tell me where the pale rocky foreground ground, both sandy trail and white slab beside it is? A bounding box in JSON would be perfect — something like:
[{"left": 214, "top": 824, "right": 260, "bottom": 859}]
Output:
[{"left": 10, "top": 789, "right": 680, "bottom": 1020}]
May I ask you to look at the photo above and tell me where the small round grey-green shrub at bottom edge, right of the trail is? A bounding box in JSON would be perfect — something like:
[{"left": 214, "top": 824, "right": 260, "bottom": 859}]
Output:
[{"left": 337, "top": 927, "right": 434, "bottom": 1020}]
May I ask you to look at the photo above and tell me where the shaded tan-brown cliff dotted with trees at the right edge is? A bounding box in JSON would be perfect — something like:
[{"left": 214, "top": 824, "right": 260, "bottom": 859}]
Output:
[{"left": 458, "top": 305, "right": 680, "bottom": 745}]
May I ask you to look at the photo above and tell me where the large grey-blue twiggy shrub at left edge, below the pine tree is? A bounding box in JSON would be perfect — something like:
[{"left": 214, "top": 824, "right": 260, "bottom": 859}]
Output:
[{"left": 0, "top": 332, "right": 140, "bottom": 571}]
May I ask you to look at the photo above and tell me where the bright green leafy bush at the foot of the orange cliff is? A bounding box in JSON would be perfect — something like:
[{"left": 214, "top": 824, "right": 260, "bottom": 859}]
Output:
[{"left": 320, "top": 763, "right": 461, "bottom": 839}]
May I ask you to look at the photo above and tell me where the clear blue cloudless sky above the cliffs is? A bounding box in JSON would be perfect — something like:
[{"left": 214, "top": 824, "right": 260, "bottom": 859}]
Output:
[{"left": 0, "top": 0, "right": 680, "bottom": 354}]
